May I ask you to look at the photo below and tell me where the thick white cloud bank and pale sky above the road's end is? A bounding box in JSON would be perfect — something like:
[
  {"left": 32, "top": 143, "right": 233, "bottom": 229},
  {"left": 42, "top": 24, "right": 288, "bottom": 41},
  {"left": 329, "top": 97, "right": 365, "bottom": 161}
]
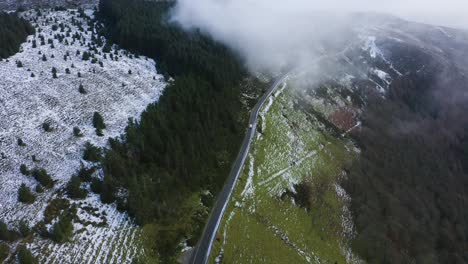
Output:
[{"left": 172, "top": 0, "right": 468, "bottom": 72}]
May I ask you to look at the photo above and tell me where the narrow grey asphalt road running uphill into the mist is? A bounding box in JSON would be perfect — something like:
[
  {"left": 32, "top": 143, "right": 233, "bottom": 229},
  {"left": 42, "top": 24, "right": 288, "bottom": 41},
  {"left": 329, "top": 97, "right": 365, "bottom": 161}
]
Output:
[{"left": 189, "top": 74, "right": 288, "bottom": 264}]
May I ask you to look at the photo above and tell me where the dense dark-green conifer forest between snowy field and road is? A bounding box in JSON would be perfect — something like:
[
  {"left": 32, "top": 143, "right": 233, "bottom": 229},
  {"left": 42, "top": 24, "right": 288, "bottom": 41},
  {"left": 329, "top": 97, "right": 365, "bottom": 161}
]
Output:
[{"left": 95, "top": 0, "right": 254, "bottom": 263}]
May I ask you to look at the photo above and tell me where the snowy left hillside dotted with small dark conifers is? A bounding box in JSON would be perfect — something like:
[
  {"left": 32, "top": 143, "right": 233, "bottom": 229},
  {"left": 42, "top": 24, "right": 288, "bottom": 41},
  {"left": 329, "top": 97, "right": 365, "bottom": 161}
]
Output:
[{"left": 0, "top": 7, "right": 166, "bottom": 263}]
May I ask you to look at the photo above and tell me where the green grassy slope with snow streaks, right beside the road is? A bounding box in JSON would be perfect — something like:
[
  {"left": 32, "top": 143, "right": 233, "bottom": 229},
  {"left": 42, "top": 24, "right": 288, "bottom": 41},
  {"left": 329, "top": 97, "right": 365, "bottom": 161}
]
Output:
[{"left": 210, "top": 83, "right": 355, "bottom": 263}]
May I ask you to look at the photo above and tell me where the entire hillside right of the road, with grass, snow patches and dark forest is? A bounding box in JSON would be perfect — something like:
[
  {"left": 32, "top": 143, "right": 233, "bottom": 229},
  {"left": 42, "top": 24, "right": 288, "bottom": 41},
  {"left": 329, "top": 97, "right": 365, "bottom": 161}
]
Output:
[{"left": 211, "top": 15, "right": 468, "bottom": 263}]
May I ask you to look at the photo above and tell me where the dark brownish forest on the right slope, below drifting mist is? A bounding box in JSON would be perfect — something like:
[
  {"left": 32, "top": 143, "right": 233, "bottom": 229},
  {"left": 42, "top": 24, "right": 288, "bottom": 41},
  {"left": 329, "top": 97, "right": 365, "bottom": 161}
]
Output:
[{"left": 344, "top": 61, "right": 468, "bottom": 264}]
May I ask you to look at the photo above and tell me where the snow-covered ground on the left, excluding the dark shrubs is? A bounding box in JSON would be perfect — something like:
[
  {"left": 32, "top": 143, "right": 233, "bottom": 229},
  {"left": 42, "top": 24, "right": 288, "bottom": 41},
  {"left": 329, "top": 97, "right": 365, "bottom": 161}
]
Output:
[{"left": 0, "top": 10, "right": 166, "bottom": 263}]
